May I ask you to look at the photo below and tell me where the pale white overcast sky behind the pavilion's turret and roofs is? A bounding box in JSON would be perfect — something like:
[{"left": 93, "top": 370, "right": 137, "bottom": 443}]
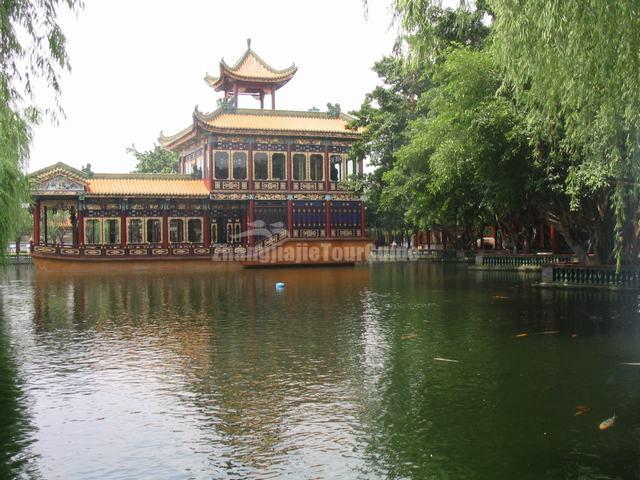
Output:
[{"left": 29, "top": 0, "right": 395, "bottom": 172}]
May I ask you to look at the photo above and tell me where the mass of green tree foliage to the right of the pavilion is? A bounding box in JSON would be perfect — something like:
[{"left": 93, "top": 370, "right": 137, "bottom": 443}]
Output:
[{"left": 354, "top": 0, "right": 640, "bottom": 262}]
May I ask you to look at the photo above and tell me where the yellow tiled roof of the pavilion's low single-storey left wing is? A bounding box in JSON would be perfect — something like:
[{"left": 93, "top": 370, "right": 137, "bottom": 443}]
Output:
[{"left": 87, "top": 174, "right": 209, "bottom": 197}]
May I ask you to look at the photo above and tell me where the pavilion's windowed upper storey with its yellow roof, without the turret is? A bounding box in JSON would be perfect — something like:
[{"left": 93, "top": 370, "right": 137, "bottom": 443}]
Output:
[{"left": 160, "top": 108, "right": 363, "bottom": 200}]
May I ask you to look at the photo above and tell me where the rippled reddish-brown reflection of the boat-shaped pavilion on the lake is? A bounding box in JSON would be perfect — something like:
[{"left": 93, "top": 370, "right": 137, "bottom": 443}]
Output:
[{"left": 27, "top": 269, "right": 376, "bottom": 477}]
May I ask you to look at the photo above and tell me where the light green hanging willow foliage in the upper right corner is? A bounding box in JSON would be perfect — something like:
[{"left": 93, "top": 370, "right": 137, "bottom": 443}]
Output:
[{"left": 492, "top": 0, "right": 640, "bottom": 264}]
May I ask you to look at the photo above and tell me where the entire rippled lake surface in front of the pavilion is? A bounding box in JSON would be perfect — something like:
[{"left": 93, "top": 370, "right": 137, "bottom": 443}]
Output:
[{"left": 0, "top": 262, "right": 640, "bottom": 480}]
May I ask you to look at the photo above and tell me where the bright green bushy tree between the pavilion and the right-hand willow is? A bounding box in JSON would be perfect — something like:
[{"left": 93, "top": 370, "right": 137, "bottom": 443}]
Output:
[{"left": 383, "top": 48, "right": 539, "bottom": 251}]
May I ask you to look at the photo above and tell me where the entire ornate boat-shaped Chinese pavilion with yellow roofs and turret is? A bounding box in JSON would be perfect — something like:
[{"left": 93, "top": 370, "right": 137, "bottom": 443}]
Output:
[{"left": 32, "top": 40, "right": 370, "bottom": 270}]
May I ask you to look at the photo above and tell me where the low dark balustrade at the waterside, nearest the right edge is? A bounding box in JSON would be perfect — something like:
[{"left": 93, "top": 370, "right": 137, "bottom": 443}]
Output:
[{"left": 542, "top": 265, "right": 640, "bottom": 288}]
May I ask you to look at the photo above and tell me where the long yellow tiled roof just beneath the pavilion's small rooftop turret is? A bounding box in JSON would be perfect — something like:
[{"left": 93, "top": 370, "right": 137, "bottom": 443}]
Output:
[{"left": 201, "top": 109, "right": 358, "bottom": 135}]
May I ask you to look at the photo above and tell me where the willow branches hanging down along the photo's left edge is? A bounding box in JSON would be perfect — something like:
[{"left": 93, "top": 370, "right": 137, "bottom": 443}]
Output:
[{"left": 0, "top": 0, "right": 81, "bottom": 259}]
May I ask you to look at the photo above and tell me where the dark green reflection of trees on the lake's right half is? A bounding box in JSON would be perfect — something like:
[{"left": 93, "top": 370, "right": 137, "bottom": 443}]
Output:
[{"left": 359, "top": 264, "right": 640, "bottom": 478}]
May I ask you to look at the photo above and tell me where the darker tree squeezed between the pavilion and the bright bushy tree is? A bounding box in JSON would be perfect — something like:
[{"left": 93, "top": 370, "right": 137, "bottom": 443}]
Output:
[{"left": 351, "top": 6, "right": 489, "bottom": 242}]
